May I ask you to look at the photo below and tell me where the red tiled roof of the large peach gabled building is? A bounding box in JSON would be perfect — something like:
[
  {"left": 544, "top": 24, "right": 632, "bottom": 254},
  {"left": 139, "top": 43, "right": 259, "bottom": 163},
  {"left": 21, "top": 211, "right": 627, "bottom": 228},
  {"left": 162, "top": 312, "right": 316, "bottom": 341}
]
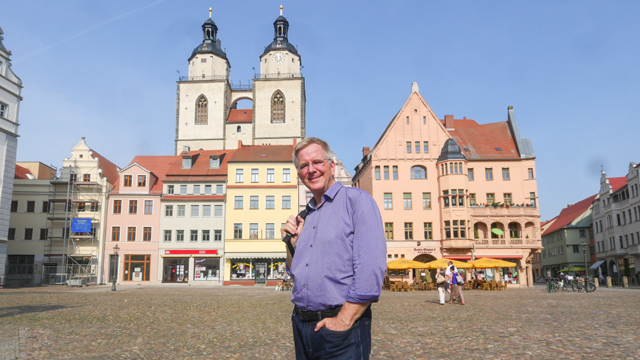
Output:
[{"left": 448, "top": 119, "right": 520, "bottom": 160}]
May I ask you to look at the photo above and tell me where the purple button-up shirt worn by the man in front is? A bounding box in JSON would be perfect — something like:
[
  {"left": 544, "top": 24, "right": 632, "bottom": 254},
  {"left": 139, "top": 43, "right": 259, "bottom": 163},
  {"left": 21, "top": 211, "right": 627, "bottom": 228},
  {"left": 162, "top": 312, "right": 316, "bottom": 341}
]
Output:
[{"left": 290, "top": 183, "right": 387, "bottom": 311}]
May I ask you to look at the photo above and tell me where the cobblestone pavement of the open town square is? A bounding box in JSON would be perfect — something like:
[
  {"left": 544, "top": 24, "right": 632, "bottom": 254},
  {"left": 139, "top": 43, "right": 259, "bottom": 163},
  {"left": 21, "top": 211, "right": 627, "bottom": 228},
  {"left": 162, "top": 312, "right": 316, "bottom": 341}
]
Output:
[{"left": 0, "top": 286, "right": 640, "bottom": 360}]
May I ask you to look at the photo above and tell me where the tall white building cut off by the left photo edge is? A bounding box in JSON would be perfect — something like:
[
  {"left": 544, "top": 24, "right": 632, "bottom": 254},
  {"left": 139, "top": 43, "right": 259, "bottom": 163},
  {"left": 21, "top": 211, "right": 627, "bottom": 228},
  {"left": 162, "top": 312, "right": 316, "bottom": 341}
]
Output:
[{"left": 0, "top": 28, "right": 22, "bottom": 286}]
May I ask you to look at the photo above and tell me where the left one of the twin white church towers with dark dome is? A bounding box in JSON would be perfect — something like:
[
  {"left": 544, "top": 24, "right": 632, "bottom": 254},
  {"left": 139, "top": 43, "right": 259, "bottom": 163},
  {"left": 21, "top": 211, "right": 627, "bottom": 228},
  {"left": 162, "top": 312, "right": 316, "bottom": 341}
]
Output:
[{"left": 175, "top": 8, "right": 231, "bottom": 155}]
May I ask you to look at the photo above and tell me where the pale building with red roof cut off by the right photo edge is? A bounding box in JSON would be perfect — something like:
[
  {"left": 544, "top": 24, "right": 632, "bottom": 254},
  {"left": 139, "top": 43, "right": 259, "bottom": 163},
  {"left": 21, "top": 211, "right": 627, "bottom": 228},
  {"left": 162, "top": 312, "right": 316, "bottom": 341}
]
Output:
[{"left": 592, "top": 163, "right": 640, "bottom": 284}]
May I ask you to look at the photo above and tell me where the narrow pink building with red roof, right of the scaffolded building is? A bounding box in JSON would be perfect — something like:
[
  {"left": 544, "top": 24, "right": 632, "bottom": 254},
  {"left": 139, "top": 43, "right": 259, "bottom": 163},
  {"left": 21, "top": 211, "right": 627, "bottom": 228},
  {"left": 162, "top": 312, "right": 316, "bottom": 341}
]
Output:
[{"left": 104, "top": 156, "right": 176, "bottom": 284}]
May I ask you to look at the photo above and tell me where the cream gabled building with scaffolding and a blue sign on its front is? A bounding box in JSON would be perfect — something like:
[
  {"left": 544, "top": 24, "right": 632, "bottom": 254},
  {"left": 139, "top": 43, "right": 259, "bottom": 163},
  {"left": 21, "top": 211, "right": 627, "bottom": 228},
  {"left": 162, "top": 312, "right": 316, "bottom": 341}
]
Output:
[{"left": 43, "top": 165, "right": 103, "bottom": 284}]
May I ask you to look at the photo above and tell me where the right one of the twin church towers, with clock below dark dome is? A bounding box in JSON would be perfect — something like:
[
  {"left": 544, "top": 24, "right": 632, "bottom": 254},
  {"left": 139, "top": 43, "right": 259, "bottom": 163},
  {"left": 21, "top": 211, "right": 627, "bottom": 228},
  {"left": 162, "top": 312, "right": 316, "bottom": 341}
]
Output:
[{"left": 253, "top": 6, "right": 306, "bottom": 145}]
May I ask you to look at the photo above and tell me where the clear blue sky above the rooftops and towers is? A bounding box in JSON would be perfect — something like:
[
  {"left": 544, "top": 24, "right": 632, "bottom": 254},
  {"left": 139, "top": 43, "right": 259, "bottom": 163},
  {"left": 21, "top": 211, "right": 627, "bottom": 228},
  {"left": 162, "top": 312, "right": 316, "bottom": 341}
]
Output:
[{"left": 0, "top": 0, "right": 640, "bottom": 220}]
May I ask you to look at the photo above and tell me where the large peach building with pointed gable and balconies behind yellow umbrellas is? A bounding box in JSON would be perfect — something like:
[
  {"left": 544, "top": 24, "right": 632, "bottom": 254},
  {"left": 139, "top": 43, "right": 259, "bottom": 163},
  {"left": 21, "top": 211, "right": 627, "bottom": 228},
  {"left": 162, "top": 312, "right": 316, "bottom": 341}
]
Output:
[{"left": 353, "top": 83, "right": 542, "bottom": 285}]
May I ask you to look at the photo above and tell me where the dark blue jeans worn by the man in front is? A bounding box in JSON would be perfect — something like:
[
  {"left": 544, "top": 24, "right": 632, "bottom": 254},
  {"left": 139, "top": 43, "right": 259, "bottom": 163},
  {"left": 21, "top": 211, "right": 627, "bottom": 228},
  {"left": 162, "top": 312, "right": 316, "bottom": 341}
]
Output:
[{"left": 291, "top": 307, "right": 371, "bottom": 360}]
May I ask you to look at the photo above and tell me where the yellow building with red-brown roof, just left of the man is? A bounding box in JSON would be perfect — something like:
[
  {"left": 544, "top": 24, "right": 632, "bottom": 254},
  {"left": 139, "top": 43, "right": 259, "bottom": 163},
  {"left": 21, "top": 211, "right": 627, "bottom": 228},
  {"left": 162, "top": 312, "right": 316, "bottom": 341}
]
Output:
[{"left": 224, "top": 141, "right": 298, "bottom": 285}]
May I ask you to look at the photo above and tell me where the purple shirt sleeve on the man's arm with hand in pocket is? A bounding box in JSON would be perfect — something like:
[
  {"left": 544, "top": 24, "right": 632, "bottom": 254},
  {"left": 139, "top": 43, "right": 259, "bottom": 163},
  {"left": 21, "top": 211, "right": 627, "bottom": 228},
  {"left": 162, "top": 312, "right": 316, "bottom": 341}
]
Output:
[{"left": 346, "top": 192, "right": 387, "bottom": 303}]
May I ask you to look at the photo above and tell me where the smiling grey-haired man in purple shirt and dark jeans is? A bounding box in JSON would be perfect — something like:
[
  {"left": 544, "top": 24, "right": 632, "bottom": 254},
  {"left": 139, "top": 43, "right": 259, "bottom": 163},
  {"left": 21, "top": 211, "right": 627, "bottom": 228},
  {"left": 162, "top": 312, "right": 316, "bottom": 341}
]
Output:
[{"left": 281, "top": 137, "right": 387, "bottom": 359}]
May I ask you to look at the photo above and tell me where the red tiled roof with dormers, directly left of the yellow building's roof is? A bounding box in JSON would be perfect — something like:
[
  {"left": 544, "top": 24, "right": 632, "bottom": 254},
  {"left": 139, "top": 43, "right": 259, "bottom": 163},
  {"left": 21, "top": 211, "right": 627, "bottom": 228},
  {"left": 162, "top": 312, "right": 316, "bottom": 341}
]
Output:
[{"left": 167, "top": 150, "right": 236, "bottom": 176}]
